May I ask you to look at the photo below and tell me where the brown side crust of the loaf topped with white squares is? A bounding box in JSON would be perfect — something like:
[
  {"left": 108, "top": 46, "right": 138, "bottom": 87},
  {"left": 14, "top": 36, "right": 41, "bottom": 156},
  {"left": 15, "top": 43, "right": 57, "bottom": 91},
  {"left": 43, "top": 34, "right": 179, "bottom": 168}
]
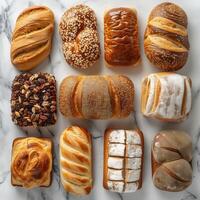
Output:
[{"left": 103, "top": 128, "right": 144, "bottom": 190}]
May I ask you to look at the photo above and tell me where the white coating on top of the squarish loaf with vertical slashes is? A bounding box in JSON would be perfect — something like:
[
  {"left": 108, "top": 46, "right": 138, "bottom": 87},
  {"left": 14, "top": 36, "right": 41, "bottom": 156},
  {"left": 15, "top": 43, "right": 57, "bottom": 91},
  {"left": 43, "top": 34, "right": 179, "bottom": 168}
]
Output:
[{"left": 144, "top": 73, "right": 191, "bottom": 119}]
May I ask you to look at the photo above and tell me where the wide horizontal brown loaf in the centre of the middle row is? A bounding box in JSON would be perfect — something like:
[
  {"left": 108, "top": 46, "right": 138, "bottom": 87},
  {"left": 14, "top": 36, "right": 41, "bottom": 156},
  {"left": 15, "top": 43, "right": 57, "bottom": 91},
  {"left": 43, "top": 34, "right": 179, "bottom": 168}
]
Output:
[{"left": 59, "top": 75, "right": 134, "bottom": 119}]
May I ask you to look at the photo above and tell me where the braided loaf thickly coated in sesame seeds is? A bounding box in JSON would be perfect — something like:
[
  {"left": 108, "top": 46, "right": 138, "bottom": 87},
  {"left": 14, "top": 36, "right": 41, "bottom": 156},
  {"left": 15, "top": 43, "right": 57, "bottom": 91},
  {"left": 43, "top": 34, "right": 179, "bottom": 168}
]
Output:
[{"left": 59, "top": 5, "right": 100, "bottom": 68}]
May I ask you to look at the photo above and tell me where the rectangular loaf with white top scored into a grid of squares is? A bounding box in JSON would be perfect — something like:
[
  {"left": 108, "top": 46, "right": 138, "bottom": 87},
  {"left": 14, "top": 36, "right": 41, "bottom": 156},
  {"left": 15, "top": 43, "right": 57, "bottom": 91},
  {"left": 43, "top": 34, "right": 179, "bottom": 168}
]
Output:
[{"left": 103, "top": 129, "right": 144, "bottom": 193}]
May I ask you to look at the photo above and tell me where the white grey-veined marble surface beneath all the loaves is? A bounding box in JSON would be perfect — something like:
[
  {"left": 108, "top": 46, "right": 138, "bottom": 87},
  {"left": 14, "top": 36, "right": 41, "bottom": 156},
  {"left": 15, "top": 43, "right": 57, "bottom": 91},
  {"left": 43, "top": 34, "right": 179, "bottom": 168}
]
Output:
[{"left": 0, "top": 0, "right": 200, "bottom": 200}]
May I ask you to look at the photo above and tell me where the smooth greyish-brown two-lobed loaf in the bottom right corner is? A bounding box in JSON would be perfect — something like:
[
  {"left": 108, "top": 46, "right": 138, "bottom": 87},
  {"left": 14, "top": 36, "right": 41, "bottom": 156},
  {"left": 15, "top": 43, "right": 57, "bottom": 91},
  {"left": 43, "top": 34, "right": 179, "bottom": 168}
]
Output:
[{"left": 152, "top": 130, "right": 192, "bottom": 192}]
